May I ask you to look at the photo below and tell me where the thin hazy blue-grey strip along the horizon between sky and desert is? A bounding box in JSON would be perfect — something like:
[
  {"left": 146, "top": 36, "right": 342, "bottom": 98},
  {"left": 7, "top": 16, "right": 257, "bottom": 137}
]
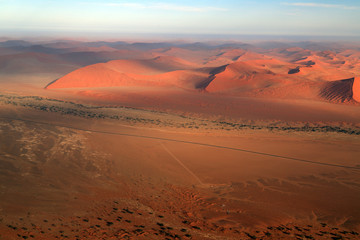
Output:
[{"left": 0, "top": 32, "right": 360, "bottom": 42}]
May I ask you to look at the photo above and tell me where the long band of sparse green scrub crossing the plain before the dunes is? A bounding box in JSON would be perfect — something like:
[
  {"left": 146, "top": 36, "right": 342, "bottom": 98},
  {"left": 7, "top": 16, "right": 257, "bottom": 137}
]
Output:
[{"left": 0, "top": 95, "right": 360, "bottom": 135}]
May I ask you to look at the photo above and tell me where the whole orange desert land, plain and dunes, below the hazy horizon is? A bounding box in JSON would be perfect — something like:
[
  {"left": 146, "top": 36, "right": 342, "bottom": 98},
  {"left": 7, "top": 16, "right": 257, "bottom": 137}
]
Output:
[{"left": 0, "top": 40, "right": 360, "bottom": 239}]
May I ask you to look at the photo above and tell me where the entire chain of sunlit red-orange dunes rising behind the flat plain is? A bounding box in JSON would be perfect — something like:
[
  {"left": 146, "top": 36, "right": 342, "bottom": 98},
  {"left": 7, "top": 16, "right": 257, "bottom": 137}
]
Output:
[{"left": 47, "top": 48, "right": 360, "bottom": 102}]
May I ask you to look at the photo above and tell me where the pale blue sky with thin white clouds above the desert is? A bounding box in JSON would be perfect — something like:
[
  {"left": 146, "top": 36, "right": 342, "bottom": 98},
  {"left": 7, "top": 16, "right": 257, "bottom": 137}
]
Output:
[{"left": 0, "top": 0, "right": 360, "bottom": 37}]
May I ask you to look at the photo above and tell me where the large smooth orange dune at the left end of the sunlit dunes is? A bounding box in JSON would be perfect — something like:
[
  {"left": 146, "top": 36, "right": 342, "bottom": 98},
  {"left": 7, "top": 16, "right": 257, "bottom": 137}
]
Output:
[{"left": 47, "top": 56, "right": 223, "bottom": 89}]
